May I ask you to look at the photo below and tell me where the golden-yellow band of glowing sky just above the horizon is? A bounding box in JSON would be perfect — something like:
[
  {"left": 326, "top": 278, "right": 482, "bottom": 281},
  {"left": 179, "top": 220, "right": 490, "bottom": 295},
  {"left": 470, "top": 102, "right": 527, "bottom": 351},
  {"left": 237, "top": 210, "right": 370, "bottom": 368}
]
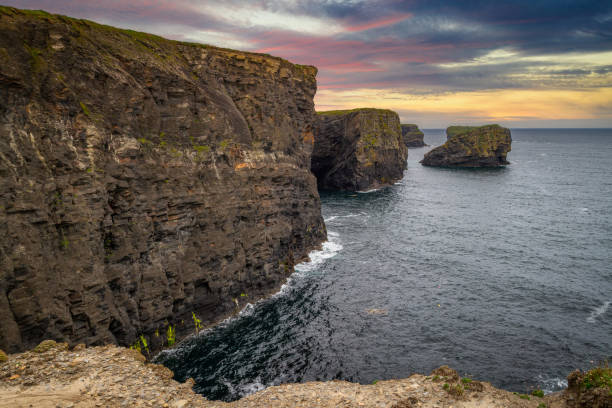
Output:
[{"left": 315, "top": 87, "right": 612, "bottom": 123}]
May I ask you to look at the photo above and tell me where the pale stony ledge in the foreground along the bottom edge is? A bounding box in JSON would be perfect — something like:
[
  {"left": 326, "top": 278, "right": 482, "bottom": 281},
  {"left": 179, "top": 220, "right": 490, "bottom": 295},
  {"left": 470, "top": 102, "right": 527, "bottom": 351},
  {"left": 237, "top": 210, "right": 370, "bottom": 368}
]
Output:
[{"left": 0, "top": 341, "right": 612, "bottom": 408}]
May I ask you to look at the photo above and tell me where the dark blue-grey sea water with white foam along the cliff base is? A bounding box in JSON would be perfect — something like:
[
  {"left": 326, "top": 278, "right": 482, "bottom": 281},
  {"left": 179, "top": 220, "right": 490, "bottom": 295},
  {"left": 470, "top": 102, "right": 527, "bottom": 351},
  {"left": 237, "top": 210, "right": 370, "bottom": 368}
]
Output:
[{"left": 159, "top": 129, "right": 612, "bottom": 400}]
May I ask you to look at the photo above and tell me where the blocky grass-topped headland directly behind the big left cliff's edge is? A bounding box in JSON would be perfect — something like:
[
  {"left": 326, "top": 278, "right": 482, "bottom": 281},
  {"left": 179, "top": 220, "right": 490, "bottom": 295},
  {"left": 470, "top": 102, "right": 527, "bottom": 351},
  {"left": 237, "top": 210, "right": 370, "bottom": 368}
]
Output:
[{"left": 311, "top": 108, "right": 408, "bottom": 191}]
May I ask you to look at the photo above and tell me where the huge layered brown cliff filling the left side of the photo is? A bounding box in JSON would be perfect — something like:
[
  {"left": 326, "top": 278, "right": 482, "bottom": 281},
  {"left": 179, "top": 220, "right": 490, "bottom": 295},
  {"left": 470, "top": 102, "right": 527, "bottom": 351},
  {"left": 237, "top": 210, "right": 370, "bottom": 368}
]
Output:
[{"left": 0, "top": 7, "right": 326, "bottom": 351}]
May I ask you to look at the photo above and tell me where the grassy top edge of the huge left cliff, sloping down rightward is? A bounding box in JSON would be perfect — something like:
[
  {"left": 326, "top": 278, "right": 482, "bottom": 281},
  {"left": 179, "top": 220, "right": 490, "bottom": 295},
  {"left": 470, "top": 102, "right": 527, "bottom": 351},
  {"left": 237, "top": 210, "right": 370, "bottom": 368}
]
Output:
[{"left": 0, "top": 5, "right": 318, "bottom": 75}]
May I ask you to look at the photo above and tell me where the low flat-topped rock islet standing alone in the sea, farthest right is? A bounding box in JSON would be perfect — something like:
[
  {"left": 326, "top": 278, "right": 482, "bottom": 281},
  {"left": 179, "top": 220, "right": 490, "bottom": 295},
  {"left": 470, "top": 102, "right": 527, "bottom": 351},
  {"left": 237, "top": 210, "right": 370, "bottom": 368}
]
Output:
[{"left": 421, "top": 125, "right": 512, "bottom": 167}]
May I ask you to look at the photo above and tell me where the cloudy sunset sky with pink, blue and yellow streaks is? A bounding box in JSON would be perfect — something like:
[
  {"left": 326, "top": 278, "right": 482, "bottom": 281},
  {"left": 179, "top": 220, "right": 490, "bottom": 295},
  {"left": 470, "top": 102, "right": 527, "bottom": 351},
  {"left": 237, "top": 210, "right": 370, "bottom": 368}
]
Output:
[{"left": 0, "top": 0, "right": 612, "bottom": 128}]
